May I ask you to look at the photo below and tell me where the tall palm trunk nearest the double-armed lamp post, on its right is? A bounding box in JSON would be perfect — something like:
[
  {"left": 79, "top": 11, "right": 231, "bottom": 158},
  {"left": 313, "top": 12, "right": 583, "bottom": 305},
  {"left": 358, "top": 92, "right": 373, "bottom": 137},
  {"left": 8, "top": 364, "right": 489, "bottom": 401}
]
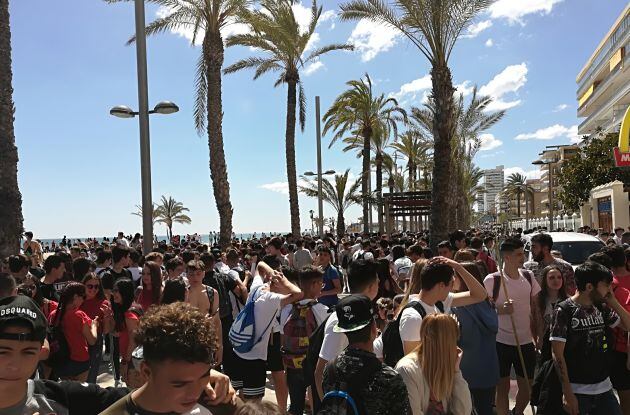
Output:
[{"left": 203, "top": 32, "right": 234, "bottom": 248}]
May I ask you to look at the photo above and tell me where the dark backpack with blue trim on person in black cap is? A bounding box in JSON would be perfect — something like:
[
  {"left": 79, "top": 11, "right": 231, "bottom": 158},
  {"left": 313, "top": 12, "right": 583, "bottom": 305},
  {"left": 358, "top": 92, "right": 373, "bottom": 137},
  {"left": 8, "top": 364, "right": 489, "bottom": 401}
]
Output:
[{"left": 317, "top": 358, "right": 382, "bottom": 415}]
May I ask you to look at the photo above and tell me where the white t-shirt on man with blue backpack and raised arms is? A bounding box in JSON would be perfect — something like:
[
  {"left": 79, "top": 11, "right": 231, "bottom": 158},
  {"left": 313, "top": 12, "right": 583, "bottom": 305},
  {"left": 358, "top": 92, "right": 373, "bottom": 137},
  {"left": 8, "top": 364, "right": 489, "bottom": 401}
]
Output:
[{"left": 234, "top": 284, "right": 284, "bottom": 360}]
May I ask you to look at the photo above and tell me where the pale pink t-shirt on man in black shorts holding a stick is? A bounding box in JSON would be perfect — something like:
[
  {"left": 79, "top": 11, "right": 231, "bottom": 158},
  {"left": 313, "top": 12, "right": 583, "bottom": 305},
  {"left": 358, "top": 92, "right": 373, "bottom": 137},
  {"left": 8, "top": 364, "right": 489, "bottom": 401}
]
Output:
[{"left": 483, "top": 271, "right": 540, "bottom": 346}]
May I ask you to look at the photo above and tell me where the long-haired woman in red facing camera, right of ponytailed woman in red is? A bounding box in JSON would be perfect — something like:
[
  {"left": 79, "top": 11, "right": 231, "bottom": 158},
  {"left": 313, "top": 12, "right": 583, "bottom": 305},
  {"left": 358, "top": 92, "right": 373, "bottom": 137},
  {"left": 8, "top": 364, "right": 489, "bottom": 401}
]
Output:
[{"left": 81, "top": 272, "right": 113, "bottom": 383}]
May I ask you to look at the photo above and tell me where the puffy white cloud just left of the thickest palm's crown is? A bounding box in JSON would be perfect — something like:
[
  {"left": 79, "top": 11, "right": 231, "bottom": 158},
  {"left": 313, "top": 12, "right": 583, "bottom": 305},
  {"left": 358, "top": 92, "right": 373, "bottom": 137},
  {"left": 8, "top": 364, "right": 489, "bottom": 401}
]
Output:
[{"left": 348, "top": 19, "right": 400, "bottom": 62}]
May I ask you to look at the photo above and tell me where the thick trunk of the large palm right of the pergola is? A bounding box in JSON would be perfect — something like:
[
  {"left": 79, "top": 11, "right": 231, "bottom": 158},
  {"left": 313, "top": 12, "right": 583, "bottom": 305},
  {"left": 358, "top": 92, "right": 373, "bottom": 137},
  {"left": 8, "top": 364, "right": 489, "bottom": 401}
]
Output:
[{"left": 430, "top": 62, "right": 455, "bottom": 252}]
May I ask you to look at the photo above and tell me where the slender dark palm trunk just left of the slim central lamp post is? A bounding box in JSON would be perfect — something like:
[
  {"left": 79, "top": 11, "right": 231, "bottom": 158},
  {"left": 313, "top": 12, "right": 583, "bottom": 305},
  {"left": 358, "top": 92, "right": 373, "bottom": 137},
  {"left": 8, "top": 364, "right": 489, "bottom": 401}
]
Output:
[{"left": 285, "top": 76, "right": 301, "bottom": 237}]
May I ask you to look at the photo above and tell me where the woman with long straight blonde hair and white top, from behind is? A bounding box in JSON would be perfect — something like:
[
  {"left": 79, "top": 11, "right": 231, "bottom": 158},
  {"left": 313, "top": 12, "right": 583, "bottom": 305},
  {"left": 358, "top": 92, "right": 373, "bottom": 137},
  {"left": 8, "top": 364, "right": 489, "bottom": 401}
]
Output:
[{"left": 396, "top": 314, "right": 472, "bottom": 415}]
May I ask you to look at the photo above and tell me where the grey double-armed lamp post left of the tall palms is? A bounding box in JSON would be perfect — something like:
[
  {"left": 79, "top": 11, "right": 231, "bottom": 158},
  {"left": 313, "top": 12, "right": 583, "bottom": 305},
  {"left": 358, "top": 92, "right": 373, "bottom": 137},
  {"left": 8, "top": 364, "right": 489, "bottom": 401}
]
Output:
[{"left": 109, "top": 99, "right": 179, "bottom": 255}]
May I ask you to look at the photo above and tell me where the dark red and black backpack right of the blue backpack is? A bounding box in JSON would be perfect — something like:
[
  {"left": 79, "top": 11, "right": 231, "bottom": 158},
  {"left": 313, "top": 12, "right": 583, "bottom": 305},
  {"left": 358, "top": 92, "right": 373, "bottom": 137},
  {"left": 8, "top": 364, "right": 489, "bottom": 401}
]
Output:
[{"left": 281, "top": 301, "right": 317, "bottom": 369}]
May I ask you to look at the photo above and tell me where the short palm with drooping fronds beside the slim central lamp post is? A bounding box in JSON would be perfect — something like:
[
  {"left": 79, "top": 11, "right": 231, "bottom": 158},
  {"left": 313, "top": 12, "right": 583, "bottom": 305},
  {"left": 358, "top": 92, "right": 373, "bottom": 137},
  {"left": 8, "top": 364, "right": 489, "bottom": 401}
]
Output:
[{"left": 300, "top": 169, "right": 362, "bottom": 238}]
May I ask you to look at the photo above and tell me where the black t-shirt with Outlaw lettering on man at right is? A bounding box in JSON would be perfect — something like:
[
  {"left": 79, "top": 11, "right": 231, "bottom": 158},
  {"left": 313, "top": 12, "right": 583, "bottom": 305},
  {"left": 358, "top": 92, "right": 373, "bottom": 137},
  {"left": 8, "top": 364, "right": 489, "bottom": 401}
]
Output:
[{"left": 550, "top": 298, "right": 620, "bottom": 385}]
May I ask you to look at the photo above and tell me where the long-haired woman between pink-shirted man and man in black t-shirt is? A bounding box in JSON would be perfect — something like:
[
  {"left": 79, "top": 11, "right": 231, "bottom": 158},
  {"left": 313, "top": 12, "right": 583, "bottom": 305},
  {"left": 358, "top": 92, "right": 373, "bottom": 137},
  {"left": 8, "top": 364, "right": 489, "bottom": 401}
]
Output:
[{"left": 532, "top": 265, "right": 568, "bottom": 350}]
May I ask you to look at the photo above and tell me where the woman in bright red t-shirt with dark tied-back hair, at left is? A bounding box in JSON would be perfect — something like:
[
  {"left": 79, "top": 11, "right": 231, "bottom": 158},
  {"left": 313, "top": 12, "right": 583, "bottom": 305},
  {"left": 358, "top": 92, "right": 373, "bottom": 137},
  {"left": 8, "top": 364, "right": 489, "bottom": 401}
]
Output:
[{"left": 49, "top": 281, "right": 98, "bottom": 382}]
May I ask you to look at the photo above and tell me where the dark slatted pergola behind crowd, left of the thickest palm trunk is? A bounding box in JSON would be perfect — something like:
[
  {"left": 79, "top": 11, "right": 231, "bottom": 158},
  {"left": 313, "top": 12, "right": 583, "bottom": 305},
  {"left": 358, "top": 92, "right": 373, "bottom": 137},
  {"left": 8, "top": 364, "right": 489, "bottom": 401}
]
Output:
[{"left": 383, "top": 190, "right": 431, "bottom": 234}]
